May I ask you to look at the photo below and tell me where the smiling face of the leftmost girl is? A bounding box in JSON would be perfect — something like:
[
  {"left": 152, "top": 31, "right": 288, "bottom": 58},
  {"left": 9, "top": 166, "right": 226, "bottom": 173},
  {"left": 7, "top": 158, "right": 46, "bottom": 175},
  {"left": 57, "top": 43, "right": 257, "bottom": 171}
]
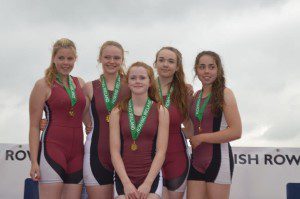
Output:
[{"left": 53, "top": 48, "right": 76, "bottom": 75}]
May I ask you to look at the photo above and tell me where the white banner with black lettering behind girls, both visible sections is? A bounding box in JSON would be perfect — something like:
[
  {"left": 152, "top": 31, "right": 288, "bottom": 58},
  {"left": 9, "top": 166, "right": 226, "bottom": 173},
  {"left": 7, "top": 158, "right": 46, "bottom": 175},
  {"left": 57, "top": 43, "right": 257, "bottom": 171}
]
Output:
[{"left": 0, "top": 144, "right": 300, "bottom": 199}]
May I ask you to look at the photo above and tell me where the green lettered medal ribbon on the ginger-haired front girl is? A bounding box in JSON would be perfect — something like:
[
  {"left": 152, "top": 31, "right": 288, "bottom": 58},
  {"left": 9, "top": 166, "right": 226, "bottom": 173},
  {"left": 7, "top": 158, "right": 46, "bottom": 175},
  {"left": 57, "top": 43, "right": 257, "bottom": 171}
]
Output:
[{"left": 128, "top": 98, "right": 153, "bottom": 141}]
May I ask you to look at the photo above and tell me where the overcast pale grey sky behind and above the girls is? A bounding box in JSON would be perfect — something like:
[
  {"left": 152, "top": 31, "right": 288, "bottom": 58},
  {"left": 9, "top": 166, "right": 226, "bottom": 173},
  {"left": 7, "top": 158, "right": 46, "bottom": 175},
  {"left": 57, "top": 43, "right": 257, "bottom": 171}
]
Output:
[{"left": 0, "top": 0, "right": 300, "bottom": 147}]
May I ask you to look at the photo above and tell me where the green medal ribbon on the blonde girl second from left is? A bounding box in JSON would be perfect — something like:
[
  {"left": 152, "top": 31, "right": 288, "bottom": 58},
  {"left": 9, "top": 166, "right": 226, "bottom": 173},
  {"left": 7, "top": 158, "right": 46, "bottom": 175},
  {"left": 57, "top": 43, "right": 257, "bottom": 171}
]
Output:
[{"left": 100, "top": 74, "right": 121, "bottom": 112}]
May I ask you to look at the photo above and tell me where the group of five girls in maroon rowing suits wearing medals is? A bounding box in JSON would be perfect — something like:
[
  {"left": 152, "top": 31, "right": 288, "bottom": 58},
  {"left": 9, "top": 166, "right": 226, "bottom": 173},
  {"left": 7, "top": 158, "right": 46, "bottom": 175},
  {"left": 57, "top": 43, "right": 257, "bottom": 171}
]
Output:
[{"left": 29, "top": 39, "right": 241, "bottom": 199}]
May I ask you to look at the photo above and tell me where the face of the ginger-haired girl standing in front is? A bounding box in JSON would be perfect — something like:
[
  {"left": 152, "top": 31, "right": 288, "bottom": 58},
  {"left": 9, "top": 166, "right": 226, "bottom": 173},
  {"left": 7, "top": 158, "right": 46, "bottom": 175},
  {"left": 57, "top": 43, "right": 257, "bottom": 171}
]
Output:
[{"left": 128, "top": 66, "right": 150, "bottom": 95}]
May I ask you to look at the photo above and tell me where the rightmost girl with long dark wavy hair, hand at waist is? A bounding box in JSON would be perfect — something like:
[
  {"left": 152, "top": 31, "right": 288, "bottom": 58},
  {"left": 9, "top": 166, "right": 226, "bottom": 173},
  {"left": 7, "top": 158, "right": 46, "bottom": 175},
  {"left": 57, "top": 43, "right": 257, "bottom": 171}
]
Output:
[{"left": 187, "top": 51, "right": 242, "bottom": 199}]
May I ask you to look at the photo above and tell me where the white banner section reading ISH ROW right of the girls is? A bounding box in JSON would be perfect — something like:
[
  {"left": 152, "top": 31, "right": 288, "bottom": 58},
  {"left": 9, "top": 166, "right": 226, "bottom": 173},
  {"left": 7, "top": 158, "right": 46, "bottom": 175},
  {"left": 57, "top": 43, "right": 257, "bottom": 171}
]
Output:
[{"left": 230, "top": 147, "right": 300, "bottom": 199}]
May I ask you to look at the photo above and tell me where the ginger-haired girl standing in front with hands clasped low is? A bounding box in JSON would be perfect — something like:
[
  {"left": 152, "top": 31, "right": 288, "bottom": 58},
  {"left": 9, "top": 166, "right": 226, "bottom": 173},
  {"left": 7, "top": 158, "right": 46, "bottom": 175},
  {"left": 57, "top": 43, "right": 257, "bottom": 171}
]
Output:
[{"left": 110, "top": 62, "right": 169, "bottom": 199}]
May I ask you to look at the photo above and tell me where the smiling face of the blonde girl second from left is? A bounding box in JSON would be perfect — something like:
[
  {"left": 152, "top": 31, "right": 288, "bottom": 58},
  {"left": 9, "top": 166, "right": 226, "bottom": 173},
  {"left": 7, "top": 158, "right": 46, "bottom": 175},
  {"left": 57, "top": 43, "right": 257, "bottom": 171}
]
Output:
[{"left": 99, "top": 45, "right": 123, "bottom": 74}]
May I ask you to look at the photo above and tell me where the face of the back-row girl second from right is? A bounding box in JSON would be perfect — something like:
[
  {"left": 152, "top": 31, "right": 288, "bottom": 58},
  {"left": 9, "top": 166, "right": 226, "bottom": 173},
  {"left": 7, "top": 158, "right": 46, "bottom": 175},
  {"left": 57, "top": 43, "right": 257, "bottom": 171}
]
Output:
[{"left": 155, "top": 49, "right": 178, "bottom": 78}]
